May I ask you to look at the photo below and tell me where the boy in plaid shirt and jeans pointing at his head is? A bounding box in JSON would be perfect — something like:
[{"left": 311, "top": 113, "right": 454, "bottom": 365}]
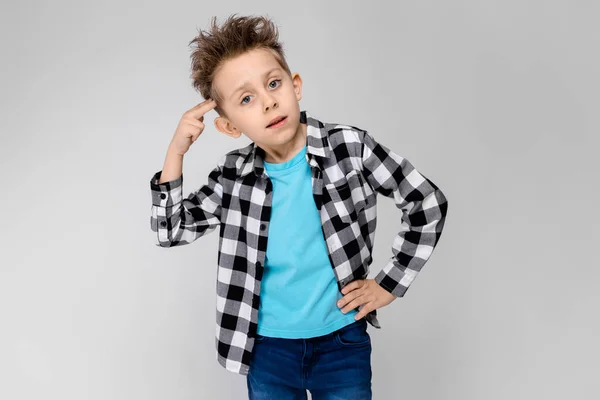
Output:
[{"left": 150, "top": 14, "right": 448, "bottom": 400}]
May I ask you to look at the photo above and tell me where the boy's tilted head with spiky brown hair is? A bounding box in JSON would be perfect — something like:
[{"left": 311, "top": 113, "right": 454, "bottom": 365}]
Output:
[{"left": 190, "top": 14, "right": 305, "bottom": 152}]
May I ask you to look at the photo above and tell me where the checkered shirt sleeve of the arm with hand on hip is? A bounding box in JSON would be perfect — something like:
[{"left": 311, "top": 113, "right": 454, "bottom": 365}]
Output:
[{"left": 362, "top": 131, "right": 448, "bottom": 297}]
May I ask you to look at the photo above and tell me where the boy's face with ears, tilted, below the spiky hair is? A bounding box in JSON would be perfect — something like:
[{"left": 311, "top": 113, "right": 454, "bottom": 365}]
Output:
[{"left": 213, "top": 49, "right": 303, "bottom": 153}]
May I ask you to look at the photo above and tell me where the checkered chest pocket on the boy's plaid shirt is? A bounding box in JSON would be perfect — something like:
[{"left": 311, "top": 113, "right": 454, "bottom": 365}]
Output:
[{"left": 325, "top": 170, "right": 368, "bottom": 224}]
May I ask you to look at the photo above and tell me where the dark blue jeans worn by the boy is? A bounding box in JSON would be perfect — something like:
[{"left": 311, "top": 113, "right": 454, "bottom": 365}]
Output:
[{"left": 246, "top": 318, "right": 372, "bottom": 400}]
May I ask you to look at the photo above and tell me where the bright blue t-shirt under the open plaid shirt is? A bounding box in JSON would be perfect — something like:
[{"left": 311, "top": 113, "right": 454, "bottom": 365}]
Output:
[{"left": 257, "top": 145, "right": 358, "bottom": 338}]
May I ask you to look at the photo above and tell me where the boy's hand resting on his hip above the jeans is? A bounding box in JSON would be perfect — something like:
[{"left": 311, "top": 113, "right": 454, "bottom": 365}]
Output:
[{"left": 337, "top": 279, "right": 398, "bottom": 321}]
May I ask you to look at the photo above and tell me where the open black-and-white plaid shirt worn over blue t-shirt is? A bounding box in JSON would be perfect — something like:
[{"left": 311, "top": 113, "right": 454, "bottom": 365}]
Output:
[{"left": 150, "top": 111, "right": 448, "bottom": 375}]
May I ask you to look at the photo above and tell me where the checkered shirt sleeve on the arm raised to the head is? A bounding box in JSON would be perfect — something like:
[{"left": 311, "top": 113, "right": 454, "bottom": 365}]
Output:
[{"left": 150, "top": 165, "right": 223, "bottom": 247}]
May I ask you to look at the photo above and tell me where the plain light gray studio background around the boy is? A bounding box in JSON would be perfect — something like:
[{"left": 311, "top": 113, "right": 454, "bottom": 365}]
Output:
[{"left": 0, "top": 0, "right": 600, "bottom": 400}]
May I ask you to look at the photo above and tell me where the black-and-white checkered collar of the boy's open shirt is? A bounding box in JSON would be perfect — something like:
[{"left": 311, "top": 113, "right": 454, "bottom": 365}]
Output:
[{"left": 237, "top": 110, "right": 332, "bottom": 177}]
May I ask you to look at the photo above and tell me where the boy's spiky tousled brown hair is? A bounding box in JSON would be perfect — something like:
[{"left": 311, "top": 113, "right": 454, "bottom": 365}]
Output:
[{"left": 189, "top": 14, "right": 292, "bottom": 115}]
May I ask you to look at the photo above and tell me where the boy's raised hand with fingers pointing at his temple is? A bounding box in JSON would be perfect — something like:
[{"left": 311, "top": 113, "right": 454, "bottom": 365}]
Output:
[{"left": 169, "top": 99, "right": 217, "bottom": 155}]
